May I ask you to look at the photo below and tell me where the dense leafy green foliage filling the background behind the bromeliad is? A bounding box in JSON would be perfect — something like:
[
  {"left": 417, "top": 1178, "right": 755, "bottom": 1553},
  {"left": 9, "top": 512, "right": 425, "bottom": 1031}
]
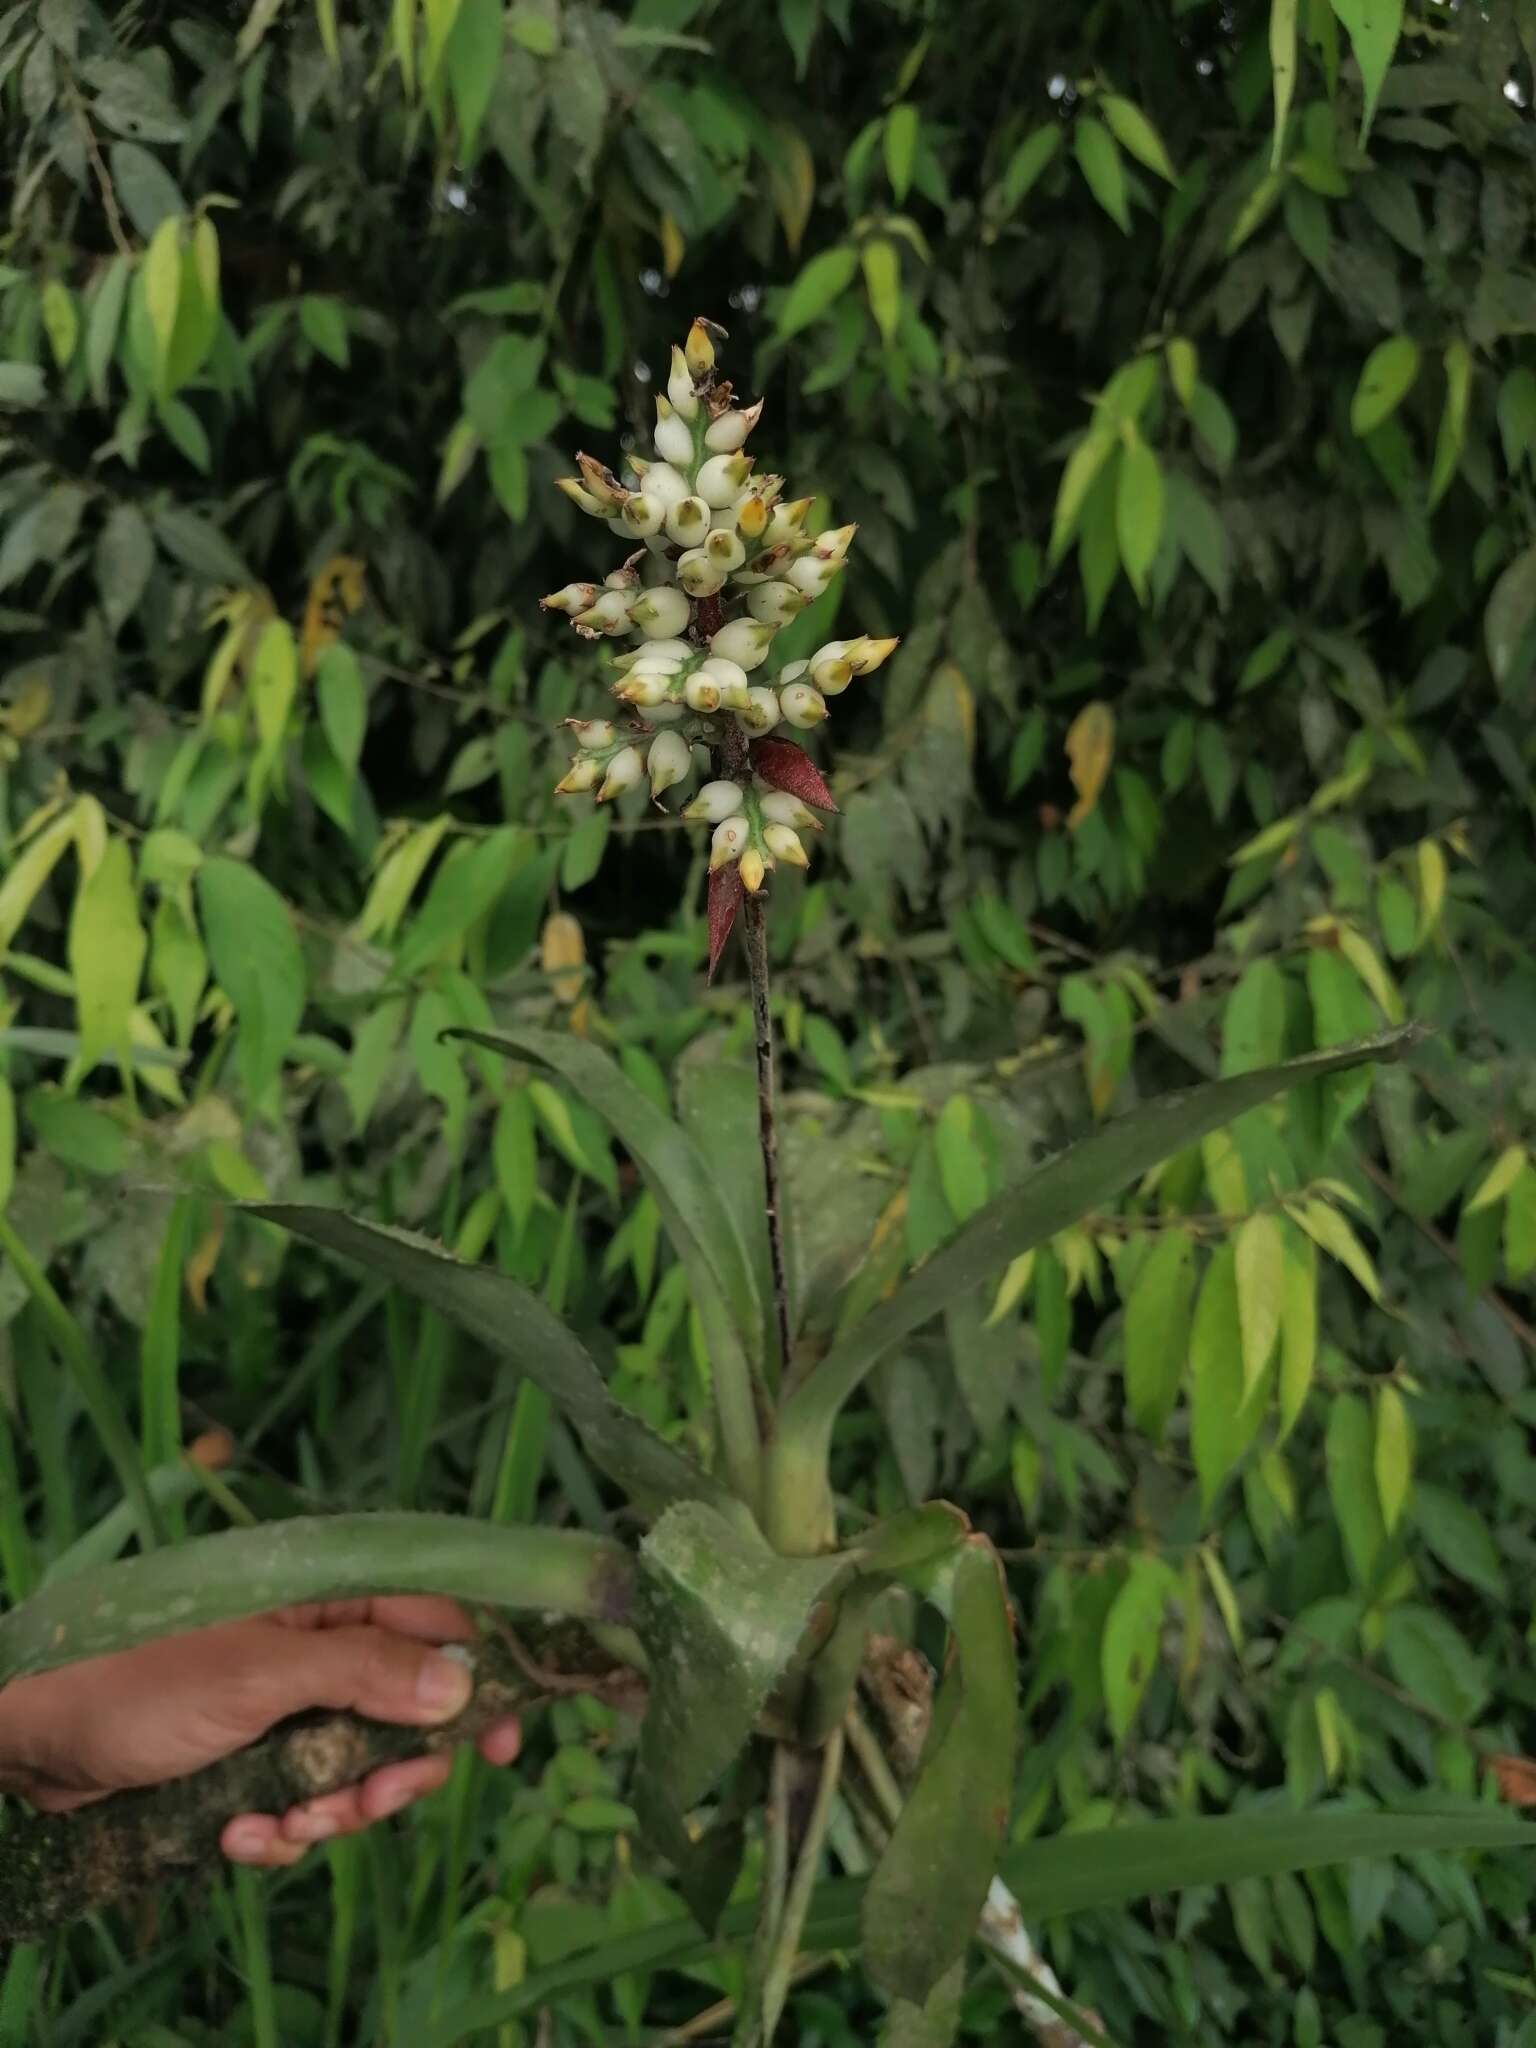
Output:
[{"left": 0, "top": 0, "right": 1536, "bottom": 2048}]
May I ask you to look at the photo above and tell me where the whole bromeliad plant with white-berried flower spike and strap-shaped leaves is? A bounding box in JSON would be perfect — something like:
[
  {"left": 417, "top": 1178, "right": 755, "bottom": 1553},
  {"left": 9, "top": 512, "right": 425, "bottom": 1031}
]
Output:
[{"left": 0, "top": 322, "right": 1522, "bottom": 2044}]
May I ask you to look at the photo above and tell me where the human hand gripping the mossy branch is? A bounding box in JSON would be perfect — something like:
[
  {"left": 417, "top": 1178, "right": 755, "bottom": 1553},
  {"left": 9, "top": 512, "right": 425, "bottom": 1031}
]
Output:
[{"left": 0, "top": 1597, "right": 520, "bottom": 1866}]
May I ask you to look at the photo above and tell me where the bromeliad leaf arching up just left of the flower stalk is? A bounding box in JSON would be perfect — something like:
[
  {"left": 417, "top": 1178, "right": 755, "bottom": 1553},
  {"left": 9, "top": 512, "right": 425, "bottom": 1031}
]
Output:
[{"left": 453, "top": 1030, "right": 764, "bottom": 1499}]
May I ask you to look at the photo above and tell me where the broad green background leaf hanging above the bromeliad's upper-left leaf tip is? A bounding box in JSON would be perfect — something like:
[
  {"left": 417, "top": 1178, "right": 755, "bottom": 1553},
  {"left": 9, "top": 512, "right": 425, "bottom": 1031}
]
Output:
[{"left": 197, "top": 856, "right": 307, "bottom": 1102}]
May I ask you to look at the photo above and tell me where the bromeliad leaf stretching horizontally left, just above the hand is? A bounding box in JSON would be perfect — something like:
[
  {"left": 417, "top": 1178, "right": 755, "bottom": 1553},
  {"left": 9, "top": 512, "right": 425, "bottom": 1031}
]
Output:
[{"left": 0, "top": 1513, "right": 635, "bottom": 1686}]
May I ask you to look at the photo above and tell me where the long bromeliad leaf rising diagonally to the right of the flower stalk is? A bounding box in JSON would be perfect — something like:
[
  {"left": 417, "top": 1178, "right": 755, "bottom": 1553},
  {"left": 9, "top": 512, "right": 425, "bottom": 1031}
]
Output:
[{"left": 778, "top": 1026, "right": 1419, "bottom": 1464}]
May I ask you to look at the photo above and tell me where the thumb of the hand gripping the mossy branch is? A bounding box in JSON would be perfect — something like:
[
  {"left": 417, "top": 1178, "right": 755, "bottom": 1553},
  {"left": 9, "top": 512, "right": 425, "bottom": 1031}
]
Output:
[{"left": 230, "top": 1624, "right": 475, "bottom": 1733}]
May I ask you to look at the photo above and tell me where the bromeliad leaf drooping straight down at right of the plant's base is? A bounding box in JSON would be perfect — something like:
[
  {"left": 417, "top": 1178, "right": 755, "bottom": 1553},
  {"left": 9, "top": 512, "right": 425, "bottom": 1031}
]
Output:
[{"left": 864, "top": 1542, "right": 1018, "bottom": 2005}]
